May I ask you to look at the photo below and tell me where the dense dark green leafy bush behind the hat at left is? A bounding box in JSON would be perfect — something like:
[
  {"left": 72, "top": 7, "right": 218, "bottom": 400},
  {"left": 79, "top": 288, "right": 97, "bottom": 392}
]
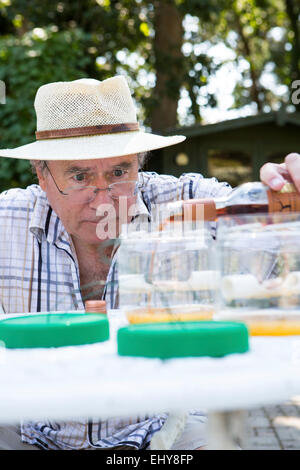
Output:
[{"left": 0, "top": 28, "right": 94, "bottom": 189}]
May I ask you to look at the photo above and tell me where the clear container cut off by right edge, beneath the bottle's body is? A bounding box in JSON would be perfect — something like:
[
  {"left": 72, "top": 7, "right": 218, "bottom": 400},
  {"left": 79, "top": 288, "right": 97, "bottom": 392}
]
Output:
[{"left": 214, "top": 213, "right": 300, "bottom": 336}]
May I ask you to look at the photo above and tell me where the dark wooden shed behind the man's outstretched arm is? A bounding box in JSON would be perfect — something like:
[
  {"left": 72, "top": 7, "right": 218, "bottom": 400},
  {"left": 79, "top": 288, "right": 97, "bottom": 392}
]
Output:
[{"left": 146, "top": 108, "right": 300, "bottom": 186}]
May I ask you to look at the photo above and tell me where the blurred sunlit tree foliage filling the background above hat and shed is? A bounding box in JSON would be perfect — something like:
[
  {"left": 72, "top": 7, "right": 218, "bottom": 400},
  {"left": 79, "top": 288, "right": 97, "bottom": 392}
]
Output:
[{"left": 0, "top": 0, "right": 300, "bottom": 189}]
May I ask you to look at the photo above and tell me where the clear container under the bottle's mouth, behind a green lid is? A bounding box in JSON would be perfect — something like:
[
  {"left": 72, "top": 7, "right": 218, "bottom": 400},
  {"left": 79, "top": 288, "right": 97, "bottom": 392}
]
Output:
[{"left": 118, "top": 223, "right": 218, "bottom": 323}]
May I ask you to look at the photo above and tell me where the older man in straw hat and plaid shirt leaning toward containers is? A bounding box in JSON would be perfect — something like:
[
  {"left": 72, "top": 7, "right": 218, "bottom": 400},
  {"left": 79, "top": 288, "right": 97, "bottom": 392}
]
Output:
[{"left": 0, "top": 77, "right": 298, "bottom": 449}]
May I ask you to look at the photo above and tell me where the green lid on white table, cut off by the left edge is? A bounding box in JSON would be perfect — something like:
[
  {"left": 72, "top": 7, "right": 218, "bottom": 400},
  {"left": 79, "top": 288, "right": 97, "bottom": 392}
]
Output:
[{"left": 0, "top": 313, "right": 109, "bottom": 348}]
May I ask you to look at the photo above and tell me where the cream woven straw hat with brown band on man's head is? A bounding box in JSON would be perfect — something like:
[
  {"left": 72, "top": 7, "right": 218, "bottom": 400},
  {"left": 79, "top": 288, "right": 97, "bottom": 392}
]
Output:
[{"left": 0, "top": 76, "right": 185, "bottom": 160}]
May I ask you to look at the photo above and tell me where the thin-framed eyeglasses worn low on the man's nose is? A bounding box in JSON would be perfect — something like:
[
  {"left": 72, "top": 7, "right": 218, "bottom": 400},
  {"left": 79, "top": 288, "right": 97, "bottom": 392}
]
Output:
[{"left": 45, "top": 162, "right": 142, "bottom": 204}]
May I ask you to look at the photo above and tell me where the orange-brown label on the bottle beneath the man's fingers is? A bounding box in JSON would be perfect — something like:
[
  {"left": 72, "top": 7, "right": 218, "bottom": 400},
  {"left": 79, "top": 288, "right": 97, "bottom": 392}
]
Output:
[{"left": 267, "top": 185, "right": 300, "bottom": 213}]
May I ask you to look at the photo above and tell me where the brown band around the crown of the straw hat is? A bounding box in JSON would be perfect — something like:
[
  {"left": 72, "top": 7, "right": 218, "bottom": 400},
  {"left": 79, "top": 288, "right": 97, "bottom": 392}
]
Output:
[{"left": 35, "top": 122, "right": 139, "bottom": 140}]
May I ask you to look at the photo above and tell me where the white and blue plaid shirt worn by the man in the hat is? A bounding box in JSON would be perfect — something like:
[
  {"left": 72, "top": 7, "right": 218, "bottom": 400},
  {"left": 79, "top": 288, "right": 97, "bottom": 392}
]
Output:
[{"left": 0, "top": 172, "right": 231, "bottom": 449}]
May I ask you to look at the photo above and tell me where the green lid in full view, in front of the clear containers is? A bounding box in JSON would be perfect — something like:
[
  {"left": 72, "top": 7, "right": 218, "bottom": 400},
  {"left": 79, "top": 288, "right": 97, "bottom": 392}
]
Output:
[{"left": 118, "top": 321, "right": 249, "bottom": 359}]
